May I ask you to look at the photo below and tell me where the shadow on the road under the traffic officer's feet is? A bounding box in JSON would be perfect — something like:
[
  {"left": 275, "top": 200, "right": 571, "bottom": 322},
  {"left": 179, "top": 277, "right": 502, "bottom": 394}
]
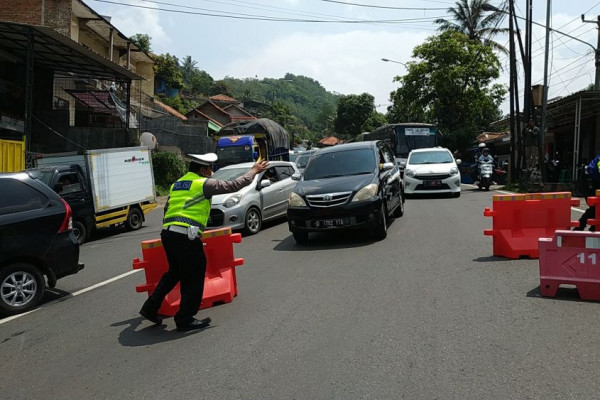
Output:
[{"left": 111, "top": 317, "right": 214, "bottom": 347}]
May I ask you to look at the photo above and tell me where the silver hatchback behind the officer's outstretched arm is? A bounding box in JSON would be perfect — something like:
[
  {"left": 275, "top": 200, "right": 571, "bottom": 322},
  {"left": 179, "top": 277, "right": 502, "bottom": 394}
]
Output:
[{"left": 207, "top": 161, "right": 299, "bottom": 235}]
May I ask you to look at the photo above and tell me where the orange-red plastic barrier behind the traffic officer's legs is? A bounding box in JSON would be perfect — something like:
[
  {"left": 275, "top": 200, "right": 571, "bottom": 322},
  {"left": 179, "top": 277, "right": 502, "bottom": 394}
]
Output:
[{"left": 133, "top": 228, "right": 244, "bottom": 316}]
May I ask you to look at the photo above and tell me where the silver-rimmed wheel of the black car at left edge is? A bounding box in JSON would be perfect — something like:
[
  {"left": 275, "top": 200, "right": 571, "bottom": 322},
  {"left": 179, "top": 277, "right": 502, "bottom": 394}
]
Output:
[{"left": 0, "top": 263, "right": 46, "bottom": 315}]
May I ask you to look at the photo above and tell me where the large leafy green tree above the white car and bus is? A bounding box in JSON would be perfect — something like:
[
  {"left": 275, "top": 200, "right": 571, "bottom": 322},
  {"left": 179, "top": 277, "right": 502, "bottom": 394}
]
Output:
[{"left": 388, "top": 31, "right": 506, "bottom": 148}]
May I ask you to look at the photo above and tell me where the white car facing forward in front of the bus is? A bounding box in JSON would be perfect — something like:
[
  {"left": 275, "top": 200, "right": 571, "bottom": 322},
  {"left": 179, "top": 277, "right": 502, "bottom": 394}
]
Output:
[{"left": 403, "top": 147, "right": 460, "bottom": 197}]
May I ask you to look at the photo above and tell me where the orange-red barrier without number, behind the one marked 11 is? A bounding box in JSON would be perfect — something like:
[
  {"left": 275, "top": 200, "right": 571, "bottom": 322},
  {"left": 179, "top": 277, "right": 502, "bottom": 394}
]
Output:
[{"left": 483, "top": 192, "right": 579, "bottom": 259}]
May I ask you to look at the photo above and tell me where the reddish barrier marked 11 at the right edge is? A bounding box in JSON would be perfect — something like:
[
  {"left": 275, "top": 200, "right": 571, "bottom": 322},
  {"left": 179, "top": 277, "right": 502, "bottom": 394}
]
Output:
[{"left": 539, "top": 230, "right": 600, "bottom": 301}]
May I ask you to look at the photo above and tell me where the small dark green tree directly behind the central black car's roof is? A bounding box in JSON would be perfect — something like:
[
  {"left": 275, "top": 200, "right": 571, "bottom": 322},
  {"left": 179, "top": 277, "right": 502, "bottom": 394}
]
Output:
[{"left": 333, "top": 93, "right": 375, "bottom": 140}]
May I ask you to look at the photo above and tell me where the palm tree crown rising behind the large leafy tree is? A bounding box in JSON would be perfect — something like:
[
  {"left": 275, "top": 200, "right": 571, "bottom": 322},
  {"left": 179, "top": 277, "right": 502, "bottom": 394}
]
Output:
[{"left": 435, "top": 0, "right": 508, "bottom": 54}]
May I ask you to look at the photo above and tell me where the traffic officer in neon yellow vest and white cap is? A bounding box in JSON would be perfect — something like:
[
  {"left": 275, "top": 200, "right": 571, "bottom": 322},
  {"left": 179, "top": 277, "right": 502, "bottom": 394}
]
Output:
[{"left": 140, "top": 153, "right": 268, "bottom": 332}]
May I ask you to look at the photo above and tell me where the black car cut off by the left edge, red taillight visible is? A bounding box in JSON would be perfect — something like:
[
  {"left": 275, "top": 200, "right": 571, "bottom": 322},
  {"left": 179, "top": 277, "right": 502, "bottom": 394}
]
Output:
[{"left": 0, "top": 172, "right": 83, "bottom": 315}]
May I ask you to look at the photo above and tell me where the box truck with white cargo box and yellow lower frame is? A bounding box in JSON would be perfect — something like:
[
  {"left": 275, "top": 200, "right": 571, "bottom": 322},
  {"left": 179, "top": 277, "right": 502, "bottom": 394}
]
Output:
[{"left": 28, "top": 147, "right": 156, "bottom": 243}]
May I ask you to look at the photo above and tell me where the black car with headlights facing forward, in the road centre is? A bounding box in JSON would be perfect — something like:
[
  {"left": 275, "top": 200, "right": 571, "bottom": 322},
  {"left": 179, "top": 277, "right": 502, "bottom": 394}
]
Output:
[{"left": 287, "top": 141, "right": 404, "bottom": 243}]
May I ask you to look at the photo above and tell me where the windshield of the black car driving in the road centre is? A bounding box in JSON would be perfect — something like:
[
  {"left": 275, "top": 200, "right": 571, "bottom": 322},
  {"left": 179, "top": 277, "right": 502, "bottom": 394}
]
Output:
[{"left": 304, "top": 148, "right": 376, "bottom": 180}]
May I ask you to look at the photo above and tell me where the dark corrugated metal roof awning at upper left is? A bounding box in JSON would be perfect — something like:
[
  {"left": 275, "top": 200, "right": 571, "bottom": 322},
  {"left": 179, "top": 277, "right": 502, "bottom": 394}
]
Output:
[{"left": 0, "top": 21, "right": 144, "bottom": 80}]
